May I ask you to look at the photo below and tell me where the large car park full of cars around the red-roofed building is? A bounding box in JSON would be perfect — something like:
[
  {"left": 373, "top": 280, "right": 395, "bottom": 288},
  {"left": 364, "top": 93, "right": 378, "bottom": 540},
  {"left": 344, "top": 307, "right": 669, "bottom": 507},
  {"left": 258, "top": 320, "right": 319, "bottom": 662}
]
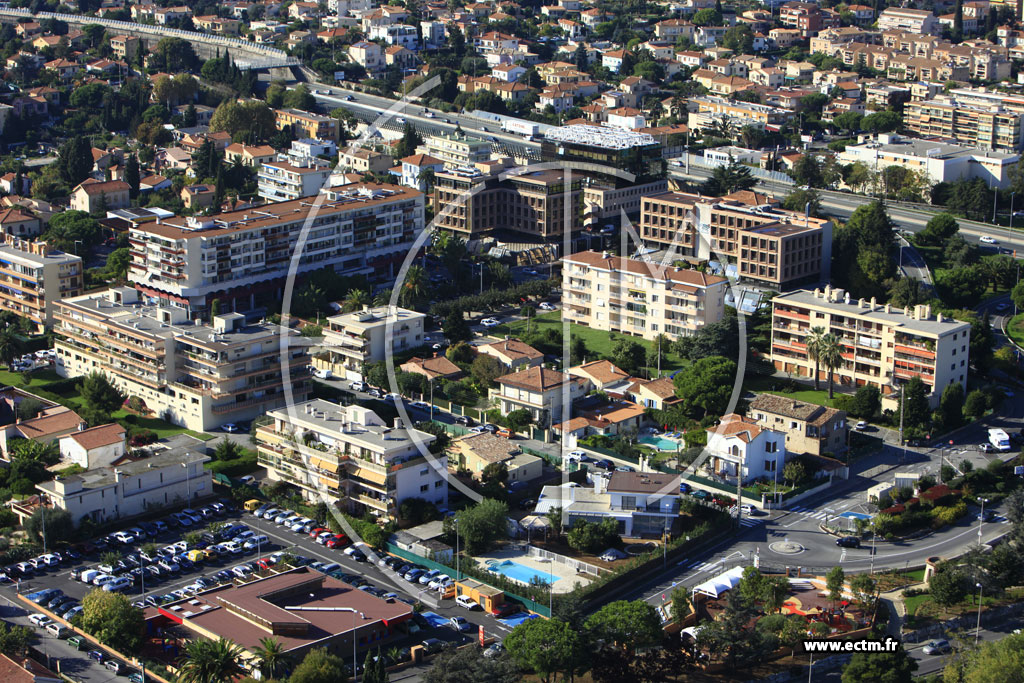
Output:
[{"left": 0, "top": 497, "right": 520, "bottom": 676}]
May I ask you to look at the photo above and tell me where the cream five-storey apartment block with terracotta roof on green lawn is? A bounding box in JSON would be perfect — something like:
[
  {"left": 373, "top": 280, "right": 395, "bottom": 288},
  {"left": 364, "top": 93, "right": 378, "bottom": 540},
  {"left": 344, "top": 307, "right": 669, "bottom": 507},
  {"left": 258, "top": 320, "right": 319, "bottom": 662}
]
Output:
[{"left": 562, "top": 251, "right": 728, "bottom": 339}]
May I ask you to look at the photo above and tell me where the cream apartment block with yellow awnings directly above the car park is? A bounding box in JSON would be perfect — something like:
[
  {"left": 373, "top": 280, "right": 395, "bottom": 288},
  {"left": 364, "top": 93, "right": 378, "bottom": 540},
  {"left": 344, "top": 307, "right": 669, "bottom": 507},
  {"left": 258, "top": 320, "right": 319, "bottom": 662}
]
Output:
[{"left": 256, "top": 398, "right": 447, "bottom": 521}]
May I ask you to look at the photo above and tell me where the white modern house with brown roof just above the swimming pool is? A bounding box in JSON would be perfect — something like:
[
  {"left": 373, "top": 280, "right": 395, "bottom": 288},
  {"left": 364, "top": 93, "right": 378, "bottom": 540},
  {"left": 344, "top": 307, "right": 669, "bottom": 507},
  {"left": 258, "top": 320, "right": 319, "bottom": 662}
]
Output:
[{"left": 534, "top": 472, "right": 680, "bottom": 538}]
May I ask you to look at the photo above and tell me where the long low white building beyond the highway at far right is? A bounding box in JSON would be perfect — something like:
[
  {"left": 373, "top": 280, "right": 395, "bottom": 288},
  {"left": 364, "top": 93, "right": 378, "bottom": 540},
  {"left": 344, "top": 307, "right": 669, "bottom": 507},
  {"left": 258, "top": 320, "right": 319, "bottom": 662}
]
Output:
[{"left": 839, "top": 135, "right": 1020, "bottom": 189}]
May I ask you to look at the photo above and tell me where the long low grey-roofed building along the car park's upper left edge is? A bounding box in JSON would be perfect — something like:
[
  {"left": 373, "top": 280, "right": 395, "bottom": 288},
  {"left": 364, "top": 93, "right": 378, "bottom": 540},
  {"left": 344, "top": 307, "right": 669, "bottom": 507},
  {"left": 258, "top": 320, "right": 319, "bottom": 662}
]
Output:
[{"left": 36, "top": 434, "right": 213, "bottom": 524}]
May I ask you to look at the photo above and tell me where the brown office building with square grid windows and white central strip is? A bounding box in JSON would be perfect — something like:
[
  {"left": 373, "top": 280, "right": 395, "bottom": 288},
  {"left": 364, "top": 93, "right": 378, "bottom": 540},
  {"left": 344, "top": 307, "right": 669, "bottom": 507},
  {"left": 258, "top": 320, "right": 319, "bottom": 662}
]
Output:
[{"left": 640, "top": 193, "right": 833, "bottom": 290}]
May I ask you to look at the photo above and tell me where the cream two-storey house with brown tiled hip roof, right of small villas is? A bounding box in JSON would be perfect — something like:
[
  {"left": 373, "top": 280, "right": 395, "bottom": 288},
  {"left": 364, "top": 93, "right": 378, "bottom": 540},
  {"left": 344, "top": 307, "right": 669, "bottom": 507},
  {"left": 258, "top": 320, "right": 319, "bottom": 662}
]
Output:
[{"left": 489, "top": 368, "right": 586, "bottom": 427}]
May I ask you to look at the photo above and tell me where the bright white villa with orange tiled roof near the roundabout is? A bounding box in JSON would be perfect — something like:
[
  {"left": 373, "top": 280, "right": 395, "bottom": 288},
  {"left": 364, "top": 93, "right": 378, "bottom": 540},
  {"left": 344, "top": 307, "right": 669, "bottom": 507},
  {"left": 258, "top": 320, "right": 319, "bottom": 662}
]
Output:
[{"left": 705, "top": 413, "right": 785, "bottom": 484}]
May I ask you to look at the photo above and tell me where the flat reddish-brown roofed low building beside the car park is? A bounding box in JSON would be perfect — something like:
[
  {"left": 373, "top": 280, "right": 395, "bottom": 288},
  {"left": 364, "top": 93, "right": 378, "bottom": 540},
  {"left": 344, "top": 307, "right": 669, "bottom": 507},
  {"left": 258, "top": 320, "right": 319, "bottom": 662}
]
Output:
[{"left": 147, "top": 567, "right": 413, "bottom": 673}]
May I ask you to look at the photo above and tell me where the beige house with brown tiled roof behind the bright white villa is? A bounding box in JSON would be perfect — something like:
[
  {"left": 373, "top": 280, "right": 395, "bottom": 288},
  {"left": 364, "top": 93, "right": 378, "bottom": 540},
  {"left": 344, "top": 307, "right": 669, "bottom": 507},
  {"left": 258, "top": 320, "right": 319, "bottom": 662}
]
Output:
[{"left": 746, "top": 393, "right": 850, "bottom": 456}]
